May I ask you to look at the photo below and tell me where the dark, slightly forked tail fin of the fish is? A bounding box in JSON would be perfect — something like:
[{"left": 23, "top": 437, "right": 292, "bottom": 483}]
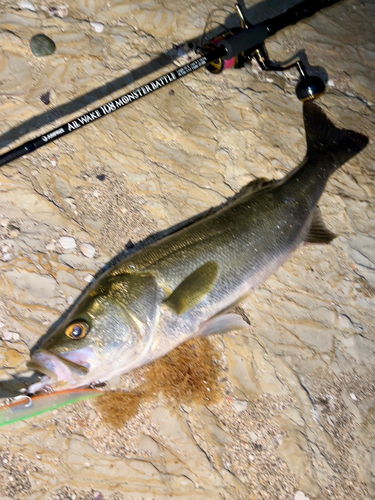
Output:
[{"left": 303, "top": 102, "right": 368, "bottom": 170}]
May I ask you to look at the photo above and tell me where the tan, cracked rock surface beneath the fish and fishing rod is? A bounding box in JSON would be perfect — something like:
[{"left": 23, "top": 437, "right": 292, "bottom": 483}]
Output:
[{"left": 0, "top": 0, "right": 375, "bottom": 500}]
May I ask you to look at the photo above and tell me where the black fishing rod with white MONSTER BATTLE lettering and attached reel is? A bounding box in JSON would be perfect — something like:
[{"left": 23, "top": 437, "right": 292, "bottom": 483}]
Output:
[{"left": 0, "top": 0, "right": 340, "bottom": 167}]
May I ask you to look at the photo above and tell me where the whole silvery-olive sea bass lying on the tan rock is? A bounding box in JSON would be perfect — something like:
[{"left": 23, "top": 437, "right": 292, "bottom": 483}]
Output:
[{"left": 29, "top": 103, "right": 368, "bottom": 393}]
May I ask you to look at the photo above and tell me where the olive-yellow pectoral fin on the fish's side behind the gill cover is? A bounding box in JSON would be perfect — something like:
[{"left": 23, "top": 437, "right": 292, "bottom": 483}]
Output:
[{"left": 164, "top": 261, "right": 219, "bottom": 315}]
